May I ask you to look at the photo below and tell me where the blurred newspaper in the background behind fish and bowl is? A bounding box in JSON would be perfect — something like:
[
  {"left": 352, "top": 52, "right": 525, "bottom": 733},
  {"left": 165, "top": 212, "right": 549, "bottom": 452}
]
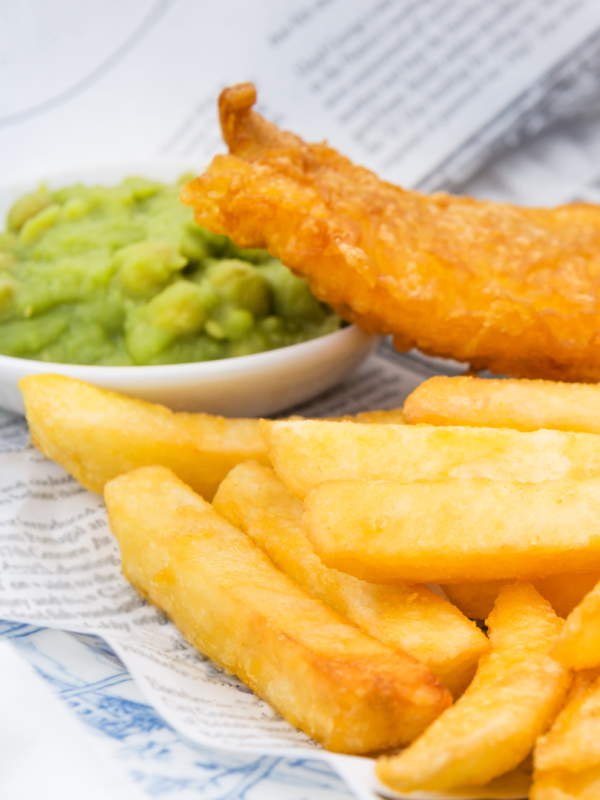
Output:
[{"left": 0, "top": 0, "right": 600, "bottom": 202}]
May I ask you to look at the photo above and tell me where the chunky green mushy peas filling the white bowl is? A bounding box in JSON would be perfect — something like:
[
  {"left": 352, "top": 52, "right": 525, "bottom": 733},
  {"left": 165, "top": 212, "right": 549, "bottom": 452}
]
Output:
[{"left": 0, "top": 176, "right": 342, "bottom": 366}]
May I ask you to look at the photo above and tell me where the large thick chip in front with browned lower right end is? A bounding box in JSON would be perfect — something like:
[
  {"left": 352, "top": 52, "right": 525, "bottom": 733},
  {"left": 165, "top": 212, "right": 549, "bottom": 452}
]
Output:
[{"left": 105, "top": 467, "right": 451, "bottom": 753}]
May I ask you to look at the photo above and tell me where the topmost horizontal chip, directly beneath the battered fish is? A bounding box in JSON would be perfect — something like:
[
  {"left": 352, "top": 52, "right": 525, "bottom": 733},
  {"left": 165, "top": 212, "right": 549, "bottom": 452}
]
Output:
[{"left": 404, "top": 376, "right": 600, "bottom": 433}]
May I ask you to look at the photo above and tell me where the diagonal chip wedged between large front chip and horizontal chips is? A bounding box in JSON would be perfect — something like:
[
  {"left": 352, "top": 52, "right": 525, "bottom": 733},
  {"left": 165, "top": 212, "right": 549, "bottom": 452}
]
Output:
[{"left": 213, "top": 461, "right": 488, "bottom": 696}]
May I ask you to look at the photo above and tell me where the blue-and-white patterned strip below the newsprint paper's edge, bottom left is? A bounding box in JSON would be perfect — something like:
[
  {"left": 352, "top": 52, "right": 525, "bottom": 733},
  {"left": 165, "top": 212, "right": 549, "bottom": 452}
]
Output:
[{"left": 0, "top": 621, "right": 352, "bottom": 800}]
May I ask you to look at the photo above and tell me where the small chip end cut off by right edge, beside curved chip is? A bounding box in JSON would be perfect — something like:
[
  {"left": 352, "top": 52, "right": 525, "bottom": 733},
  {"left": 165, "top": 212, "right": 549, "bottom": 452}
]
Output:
[{"left": 554, "top": 583, "right": 600, "bottom": 669}]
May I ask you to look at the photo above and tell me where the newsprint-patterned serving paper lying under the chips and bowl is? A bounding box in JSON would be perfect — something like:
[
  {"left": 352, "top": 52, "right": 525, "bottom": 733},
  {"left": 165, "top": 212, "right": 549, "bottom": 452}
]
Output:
[{"left": 0, "top": 345, "right": 523, "bottom": 800}]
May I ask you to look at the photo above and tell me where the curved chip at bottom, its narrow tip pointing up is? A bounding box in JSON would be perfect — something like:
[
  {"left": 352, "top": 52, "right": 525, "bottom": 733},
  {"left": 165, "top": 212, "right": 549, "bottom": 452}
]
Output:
[{"left": 377, "top": 583, "right": 570, "bottom": 791}]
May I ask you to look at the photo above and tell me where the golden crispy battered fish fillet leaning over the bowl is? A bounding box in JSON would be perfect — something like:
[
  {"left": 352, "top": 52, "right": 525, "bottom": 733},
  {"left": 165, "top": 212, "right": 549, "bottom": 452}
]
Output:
[{"left": 182, "top": 83, "right": 600, "bottom": 381}]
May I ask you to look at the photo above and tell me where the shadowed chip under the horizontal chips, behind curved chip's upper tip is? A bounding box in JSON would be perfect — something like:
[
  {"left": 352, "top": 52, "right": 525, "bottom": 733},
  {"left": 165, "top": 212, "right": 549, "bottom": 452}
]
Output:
[{"left": 442, "top": 572, "right": 600, "bottom": 619}]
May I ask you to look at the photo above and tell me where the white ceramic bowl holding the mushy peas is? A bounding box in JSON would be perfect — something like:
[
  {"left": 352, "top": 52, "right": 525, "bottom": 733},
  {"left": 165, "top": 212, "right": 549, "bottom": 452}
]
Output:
[{"left": 0, "top": 161, "right": 379, "bottom": 417}]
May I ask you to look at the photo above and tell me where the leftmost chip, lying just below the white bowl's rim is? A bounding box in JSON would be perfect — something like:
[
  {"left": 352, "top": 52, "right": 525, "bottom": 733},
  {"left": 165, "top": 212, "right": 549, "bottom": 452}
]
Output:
[{"left": 19, "top": 375, "right": 269, "bottom": 500}]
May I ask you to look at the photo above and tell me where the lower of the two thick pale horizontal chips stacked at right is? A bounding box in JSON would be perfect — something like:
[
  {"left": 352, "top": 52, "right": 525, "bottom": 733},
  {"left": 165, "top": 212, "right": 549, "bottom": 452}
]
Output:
[{"left": 304, "top": 478, "right": 600, "bottom": 580}]
